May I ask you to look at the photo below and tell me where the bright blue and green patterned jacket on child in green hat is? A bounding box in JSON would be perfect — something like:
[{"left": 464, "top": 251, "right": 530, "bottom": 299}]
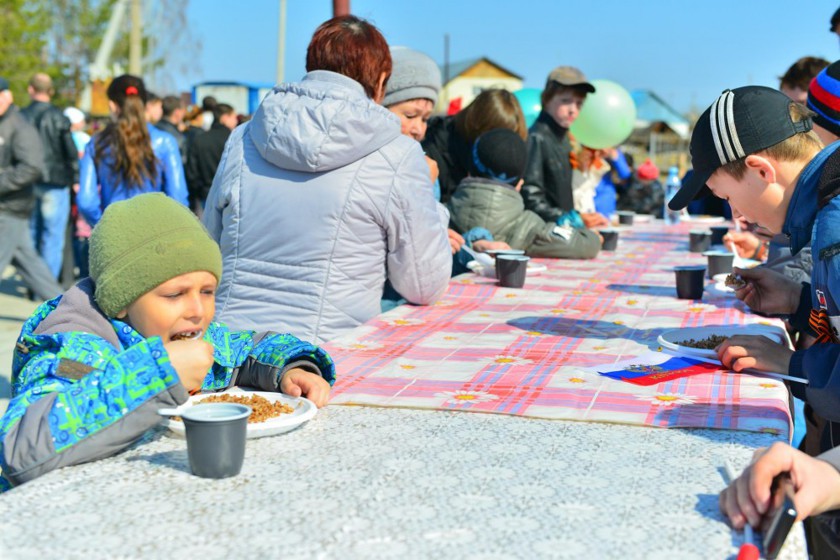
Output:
[{"left": 0, "top": 279, "right": 335, "bottom": 491}]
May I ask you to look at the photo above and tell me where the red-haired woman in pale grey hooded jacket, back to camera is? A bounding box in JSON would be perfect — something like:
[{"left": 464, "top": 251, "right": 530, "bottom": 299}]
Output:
[{"left": 204, "top": 16, "right": 451, "bottom": 343}]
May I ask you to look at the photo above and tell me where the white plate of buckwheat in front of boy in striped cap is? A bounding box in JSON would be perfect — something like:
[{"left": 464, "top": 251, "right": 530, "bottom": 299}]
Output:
[{"left": 657, "top": 324, "right": 787, "bottom": 360}]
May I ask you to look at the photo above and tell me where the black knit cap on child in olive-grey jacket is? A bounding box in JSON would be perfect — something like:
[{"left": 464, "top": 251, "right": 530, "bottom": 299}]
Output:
[{"left": 470, "top": 128, "right": 528, "bottom": 186}]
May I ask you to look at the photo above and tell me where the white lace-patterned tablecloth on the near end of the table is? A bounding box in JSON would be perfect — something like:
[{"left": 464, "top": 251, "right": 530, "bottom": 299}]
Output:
[{"left": 0, "top": 406, "right": 806, "bottom": 560}]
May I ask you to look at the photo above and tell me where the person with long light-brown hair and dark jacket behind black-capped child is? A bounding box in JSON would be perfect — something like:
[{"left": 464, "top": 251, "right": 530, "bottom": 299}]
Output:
[{"left": 422, "top": 89, "right": 528, "bottom": 204}]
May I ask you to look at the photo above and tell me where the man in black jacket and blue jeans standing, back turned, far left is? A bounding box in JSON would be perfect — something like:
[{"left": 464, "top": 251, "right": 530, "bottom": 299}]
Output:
[{"left": 21, "top": 73, "right": 79, "bottom": 278}]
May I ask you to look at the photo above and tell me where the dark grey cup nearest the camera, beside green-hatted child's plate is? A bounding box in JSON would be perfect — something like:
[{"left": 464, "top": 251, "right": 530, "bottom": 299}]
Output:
[{"left": 181, "top": 403, "right": 251, "bottom": 478}]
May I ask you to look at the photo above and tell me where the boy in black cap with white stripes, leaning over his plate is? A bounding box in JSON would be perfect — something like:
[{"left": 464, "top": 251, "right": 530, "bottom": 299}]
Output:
[{"left": 688, "top": 86, "right": 840, "bottom": 552}]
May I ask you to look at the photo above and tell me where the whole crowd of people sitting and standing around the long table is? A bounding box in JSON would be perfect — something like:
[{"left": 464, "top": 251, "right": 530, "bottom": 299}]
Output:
[{"left": 0, "top": 7, "right": 840, "bottom": 550}]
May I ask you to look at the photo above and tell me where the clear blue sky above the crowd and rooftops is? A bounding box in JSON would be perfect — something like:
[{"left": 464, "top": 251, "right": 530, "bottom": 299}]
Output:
[{"left": 178, "top": 0, "right": 840, "bottom": 111}]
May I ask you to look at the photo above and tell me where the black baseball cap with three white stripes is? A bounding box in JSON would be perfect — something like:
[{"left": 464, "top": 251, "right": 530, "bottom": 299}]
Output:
[{"left": 668, "top": 86, "right": 811, "bottom": 210}]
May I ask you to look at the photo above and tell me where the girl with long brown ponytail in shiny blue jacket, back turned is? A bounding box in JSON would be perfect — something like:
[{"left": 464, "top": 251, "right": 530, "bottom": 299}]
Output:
[{"left": 76, "top": 74, "right": 188, "bottom": 226}]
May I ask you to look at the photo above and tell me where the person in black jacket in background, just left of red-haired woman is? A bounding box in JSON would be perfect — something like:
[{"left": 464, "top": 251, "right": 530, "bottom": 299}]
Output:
[{"left": 185, "top": 103, "right": 239, "bottom": 215}]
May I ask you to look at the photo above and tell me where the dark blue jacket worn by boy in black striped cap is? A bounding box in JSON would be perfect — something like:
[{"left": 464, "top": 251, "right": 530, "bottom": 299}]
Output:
[{"left": 783, "top": 142, "right": 840, "bottom": 447}]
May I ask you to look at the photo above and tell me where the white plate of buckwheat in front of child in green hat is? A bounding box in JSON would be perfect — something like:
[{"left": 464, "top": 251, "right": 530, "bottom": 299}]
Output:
[{"left": 166, "top": 387, "right": 318, "bottom": 439}]
